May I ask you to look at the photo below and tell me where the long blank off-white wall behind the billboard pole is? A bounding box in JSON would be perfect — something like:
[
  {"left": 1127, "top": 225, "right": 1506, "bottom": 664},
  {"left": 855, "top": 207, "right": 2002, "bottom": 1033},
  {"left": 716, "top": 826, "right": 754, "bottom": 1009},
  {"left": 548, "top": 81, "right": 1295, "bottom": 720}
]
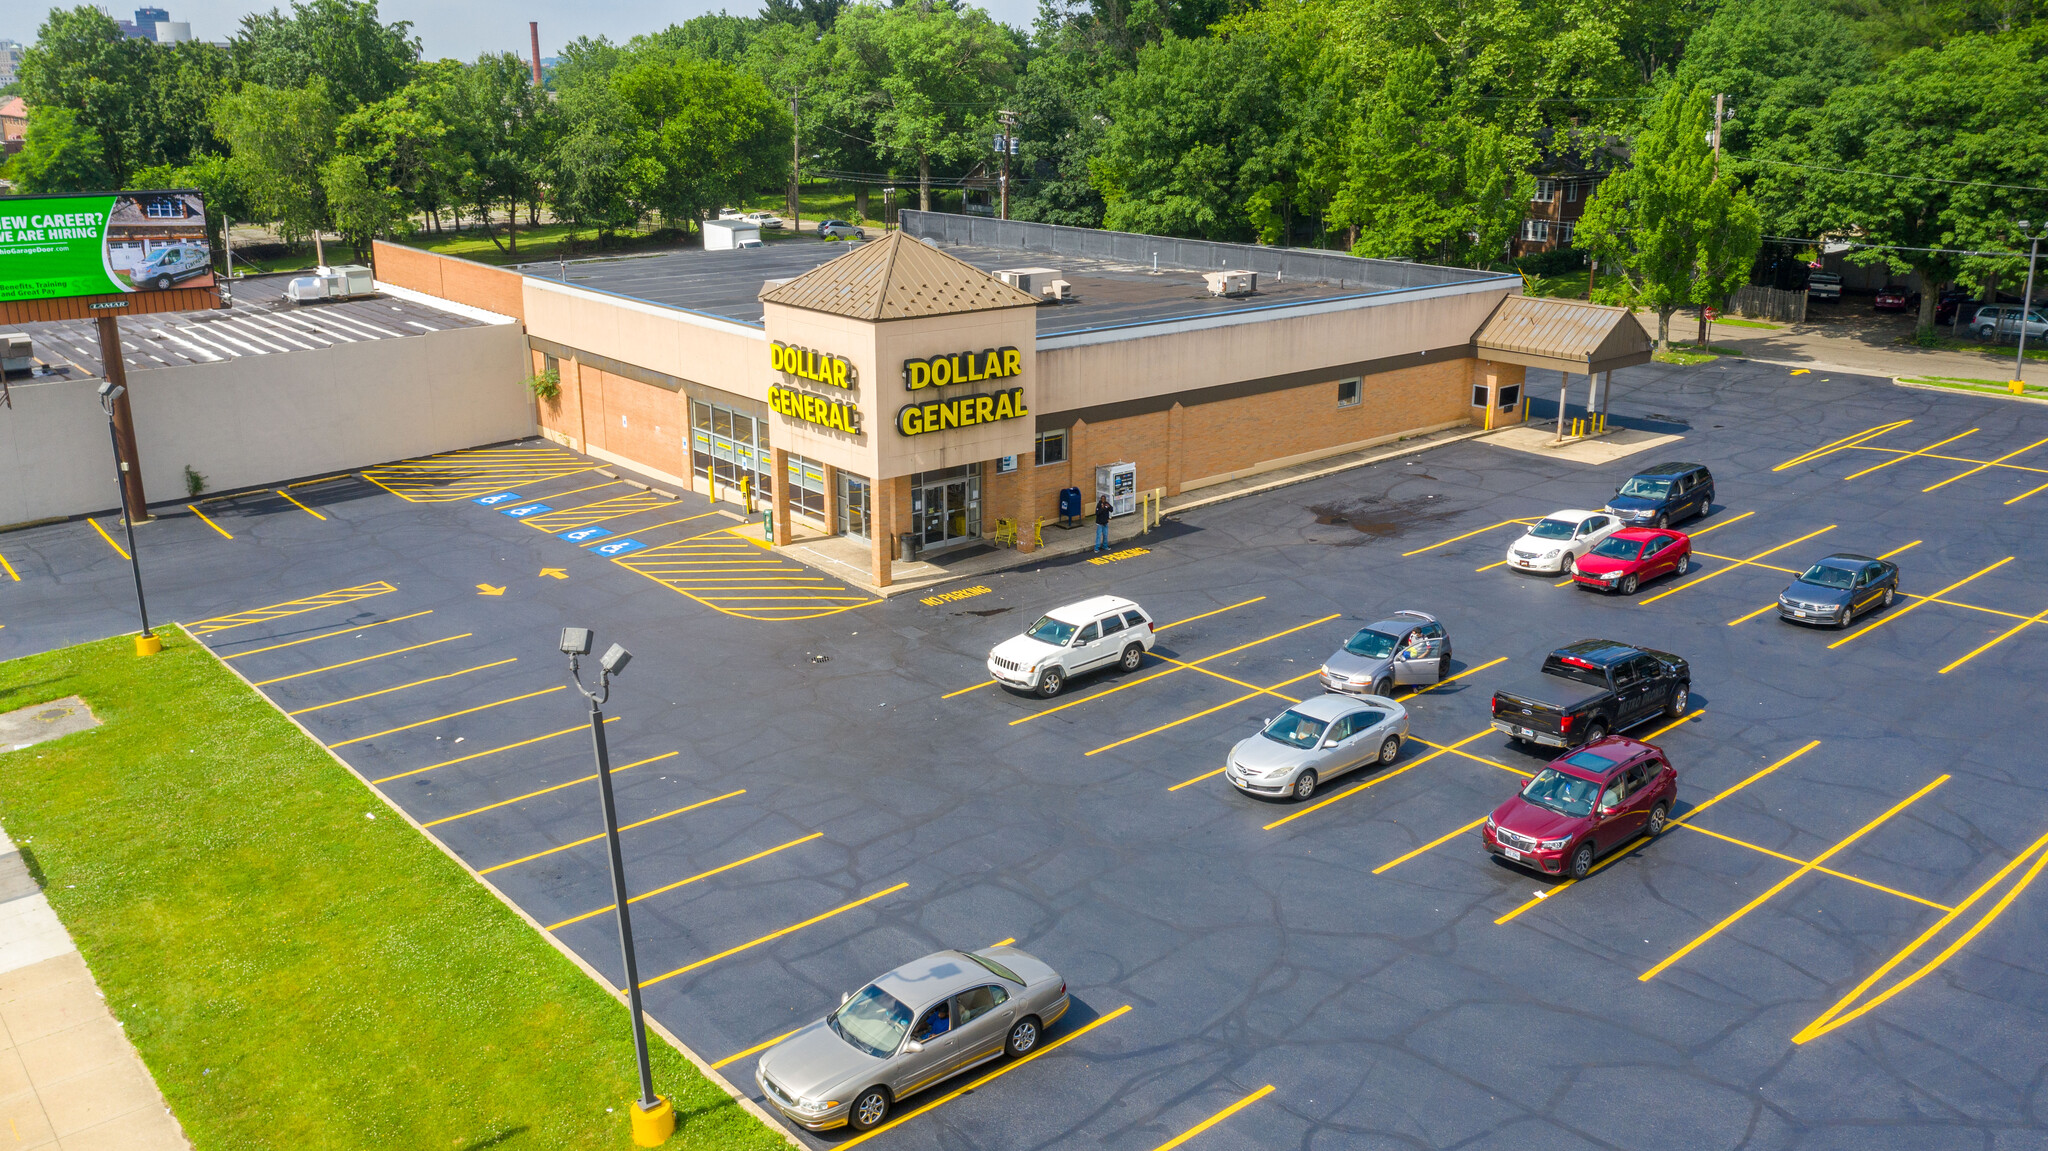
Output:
[{"left": 0, "top": 324, "right": 535, "bottom": 524}]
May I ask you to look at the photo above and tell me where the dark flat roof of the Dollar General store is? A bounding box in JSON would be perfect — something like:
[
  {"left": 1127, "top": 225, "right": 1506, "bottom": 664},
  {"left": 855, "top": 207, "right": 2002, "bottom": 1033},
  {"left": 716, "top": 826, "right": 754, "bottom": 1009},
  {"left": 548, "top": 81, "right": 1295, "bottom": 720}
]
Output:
[{"left": 514, "top": 213, "right": 1513, "bottom": 338}]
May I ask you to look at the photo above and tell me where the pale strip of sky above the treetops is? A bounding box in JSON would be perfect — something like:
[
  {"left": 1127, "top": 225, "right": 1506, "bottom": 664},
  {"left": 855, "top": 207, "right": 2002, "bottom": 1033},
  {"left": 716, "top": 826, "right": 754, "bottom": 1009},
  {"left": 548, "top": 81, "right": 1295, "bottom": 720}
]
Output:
[{"left": 0, "top": 0, "right": 1038, "bottom": 59}]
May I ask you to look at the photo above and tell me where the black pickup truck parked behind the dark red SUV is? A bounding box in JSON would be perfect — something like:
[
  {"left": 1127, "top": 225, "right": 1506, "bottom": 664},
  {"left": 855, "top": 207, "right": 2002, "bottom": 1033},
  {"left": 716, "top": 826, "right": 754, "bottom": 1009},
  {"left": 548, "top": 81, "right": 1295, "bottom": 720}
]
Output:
[{"left": 1493, "top": 639, "right": 1692, "bottom": 748}]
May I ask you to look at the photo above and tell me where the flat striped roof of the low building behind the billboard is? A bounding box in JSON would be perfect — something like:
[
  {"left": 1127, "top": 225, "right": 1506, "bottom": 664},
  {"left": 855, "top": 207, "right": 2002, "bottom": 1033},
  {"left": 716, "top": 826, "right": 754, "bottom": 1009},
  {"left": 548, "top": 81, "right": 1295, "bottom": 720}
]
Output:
[{"left": 16, "top": 274, "right": 481, "bottom": 379}]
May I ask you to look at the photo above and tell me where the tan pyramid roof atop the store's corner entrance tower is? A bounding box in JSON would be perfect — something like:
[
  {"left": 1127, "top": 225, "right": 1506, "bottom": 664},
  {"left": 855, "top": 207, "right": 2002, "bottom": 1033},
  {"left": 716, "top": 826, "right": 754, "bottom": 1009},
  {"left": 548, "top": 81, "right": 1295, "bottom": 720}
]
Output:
[{"left": 762, "top": 231, "right": 1038, "bottom": 319}]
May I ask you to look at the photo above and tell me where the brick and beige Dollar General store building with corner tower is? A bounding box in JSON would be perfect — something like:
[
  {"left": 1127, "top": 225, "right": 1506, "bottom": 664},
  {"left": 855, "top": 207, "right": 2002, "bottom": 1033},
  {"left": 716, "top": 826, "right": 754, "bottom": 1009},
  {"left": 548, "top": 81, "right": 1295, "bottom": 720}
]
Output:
[{"left": 377, "top": 211, "right": 1649, "bottom": 586}]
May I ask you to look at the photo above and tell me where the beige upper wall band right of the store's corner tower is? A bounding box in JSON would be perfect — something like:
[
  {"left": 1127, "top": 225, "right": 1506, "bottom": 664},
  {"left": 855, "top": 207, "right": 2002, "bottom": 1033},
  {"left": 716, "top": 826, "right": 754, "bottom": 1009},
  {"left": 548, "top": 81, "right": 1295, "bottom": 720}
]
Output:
[{"left": 1038, "top": 287, "right": 1507, "bottom": 414}]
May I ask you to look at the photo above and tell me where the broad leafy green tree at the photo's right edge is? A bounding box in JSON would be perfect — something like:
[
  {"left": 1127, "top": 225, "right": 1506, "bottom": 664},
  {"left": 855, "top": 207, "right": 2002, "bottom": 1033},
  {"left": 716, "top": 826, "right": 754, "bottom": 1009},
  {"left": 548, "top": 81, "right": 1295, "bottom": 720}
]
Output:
[{"left": 1753, "top": 33, "right": 2048, "bottom": 336}]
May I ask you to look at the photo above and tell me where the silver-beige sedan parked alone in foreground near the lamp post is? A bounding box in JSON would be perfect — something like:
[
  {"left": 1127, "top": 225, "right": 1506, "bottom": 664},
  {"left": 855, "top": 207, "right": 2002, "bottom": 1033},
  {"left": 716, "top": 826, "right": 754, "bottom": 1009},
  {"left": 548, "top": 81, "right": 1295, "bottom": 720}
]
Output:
[{"left": 754, "top": 946, "right": 1067, "bottom": 1131}]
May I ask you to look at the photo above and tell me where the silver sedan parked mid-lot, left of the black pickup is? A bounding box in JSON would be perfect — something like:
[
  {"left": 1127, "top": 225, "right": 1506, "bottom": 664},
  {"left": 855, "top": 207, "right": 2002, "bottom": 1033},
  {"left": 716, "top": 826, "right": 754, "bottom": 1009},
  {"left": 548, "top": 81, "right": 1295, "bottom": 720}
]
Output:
[{"left": 1223, "top": 694, "right": 1407, "bottom": 799}]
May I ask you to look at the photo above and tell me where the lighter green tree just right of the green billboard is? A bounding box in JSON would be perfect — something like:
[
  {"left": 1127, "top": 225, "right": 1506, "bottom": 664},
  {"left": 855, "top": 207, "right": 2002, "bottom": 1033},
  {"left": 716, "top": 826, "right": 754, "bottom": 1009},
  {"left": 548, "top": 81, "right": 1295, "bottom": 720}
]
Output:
[{"left": 213, "top": 78, "right": 336, "bottom": 242}]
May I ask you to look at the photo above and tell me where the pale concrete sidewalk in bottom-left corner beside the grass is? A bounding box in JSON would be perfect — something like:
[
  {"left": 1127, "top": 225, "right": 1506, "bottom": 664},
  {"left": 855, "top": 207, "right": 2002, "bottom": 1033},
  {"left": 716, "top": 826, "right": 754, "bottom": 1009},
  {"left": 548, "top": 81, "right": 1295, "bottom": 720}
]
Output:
[{"left": 0, "top": 819, "right": 190, "bottom": 1151}]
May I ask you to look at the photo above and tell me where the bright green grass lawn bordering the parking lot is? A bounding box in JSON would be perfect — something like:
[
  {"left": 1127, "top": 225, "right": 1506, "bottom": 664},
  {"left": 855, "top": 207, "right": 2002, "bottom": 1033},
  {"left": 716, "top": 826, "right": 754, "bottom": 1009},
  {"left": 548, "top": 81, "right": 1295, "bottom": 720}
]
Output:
[{"left": 0, "top": 633, "right": 786, "bottom": 1151}]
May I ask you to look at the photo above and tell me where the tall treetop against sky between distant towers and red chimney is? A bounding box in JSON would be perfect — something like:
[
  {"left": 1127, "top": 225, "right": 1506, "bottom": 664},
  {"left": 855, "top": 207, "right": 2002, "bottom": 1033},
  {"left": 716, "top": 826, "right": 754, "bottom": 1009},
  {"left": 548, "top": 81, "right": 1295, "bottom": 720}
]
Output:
[{"left": 229, "top": 0, "right": 420, "bottom": 113}]
